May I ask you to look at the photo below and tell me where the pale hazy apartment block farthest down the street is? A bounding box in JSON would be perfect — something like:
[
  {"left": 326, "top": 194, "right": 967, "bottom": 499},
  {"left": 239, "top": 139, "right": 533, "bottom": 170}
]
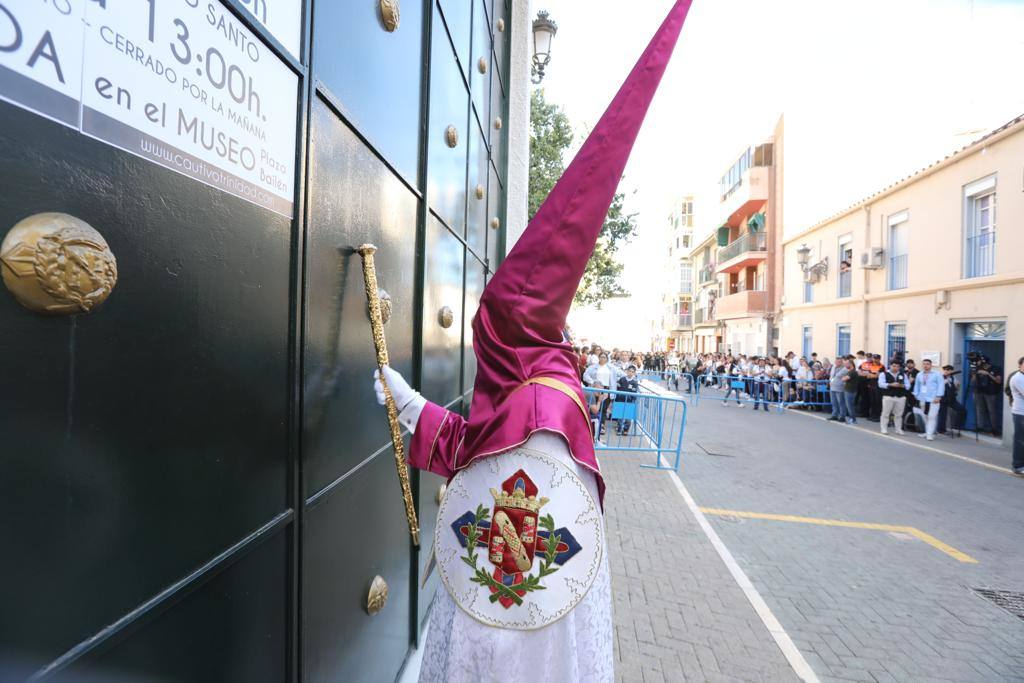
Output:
[{"left": 658, "top": 196, "right": 693, "bottom": 353}]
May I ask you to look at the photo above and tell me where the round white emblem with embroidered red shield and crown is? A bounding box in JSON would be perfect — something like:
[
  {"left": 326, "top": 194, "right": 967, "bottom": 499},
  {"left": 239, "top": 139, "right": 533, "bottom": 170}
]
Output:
[{"left": 434, "top": 449, "right": 604, "bottom": 631}]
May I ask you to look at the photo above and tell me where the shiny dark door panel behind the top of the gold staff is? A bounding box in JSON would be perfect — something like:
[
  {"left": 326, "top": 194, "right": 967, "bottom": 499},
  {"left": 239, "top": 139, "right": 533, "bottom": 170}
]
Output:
[{"left": 303, "top": 100, "right": 418, "bottom": 497}]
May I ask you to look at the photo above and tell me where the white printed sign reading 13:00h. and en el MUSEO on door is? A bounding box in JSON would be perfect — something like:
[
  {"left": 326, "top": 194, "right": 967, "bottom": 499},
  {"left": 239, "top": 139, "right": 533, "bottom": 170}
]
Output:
[{"left": 0, "top": 0, "right": 298, "bottom": 216}]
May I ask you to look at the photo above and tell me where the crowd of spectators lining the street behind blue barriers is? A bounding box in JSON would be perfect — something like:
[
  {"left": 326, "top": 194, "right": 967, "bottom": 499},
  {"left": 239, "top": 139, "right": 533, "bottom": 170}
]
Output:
[{"left": 574, "top": 344, "right": 1024, "bottom": 475}]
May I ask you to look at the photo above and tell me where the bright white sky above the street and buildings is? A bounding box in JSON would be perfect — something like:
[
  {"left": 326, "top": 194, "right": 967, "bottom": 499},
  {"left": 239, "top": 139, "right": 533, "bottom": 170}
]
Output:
[{"left": 548, "top": 0, "right": 1024, "bottom": 348}]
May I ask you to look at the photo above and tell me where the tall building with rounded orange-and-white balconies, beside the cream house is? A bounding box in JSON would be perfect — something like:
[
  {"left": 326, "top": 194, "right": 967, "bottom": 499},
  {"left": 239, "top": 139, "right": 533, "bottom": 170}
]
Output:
[{"left": 715, "top": 119, "right": 782, "bottom": 355}]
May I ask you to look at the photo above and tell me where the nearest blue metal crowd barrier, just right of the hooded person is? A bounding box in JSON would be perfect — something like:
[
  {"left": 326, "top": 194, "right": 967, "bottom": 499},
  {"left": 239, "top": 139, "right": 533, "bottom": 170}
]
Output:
[{"left": 584, "top": 387, "right": 686, "bottom": 471}]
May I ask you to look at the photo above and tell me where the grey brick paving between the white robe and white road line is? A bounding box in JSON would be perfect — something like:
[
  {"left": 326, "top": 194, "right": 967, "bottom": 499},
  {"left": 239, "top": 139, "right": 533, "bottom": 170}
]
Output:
[{"left": 601, "top": 454, "right": 799, "bottom": 683}]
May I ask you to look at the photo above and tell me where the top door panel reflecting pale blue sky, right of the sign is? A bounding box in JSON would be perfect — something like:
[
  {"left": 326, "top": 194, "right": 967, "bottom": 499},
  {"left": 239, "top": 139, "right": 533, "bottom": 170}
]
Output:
[{"left": 313, "top": 1, "right": 424, "bottom": 184}]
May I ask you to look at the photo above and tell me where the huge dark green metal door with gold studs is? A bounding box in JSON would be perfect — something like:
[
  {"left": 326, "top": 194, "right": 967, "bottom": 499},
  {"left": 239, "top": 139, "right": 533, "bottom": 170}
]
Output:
[{"left": 0, "top": 0, "right": 509, "bottom": 683}]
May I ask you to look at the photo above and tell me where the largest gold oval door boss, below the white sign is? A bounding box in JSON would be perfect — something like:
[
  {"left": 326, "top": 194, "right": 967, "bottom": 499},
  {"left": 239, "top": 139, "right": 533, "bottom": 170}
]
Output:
[{"left": 0, "top": 213, "right": 118, "bottom": 314}]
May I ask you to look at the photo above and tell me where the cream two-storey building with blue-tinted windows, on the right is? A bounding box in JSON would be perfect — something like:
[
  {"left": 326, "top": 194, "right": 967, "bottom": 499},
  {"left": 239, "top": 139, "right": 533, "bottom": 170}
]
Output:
[{"left": 780, "top": 116, "right": 1024, "bottom": 434}]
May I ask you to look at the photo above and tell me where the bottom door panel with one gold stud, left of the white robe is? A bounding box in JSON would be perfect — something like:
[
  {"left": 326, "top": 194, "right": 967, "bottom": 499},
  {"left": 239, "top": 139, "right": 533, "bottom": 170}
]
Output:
[{"left": 302, "top": 452, "right": 411, "bottom": 683}]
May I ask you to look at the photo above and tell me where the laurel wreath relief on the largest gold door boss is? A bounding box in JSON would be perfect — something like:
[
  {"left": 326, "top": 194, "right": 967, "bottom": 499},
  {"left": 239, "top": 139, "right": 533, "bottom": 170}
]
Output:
[{"left": 34, "top": 228, "right": 118, "bottom": 311}]
